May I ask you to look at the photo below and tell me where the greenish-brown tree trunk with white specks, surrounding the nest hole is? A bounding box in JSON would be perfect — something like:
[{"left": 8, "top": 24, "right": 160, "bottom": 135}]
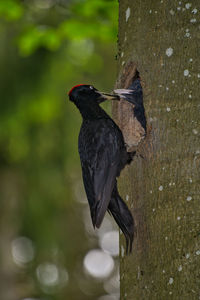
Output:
[{"left": 113, "top": 0, "right": 200, "bottom": 300}]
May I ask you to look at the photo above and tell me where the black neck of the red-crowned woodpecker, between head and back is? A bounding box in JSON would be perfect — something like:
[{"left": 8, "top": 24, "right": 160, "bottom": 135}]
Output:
[{"left": 77, "top": 102, "right": 109, "bottom": 120}]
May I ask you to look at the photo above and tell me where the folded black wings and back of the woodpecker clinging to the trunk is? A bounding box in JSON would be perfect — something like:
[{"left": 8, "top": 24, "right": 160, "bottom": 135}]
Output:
[{"left": 79, "top": 119, "right": 125, "bottom": 227}]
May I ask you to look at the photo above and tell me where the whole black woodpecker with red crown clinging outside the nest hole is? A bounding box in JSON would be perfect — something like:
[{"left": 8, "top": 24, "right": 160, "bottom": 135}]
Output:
[{"left": 68, "top": 84, "right": 135, "bottom": 254}]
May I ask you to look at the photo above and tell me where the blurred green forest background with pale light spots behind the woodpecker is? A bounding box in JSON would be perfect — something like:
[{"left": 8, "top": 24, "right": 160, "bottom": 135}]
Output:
[{"left": 0, "top": 0, "right": 119, "bottom": 300}]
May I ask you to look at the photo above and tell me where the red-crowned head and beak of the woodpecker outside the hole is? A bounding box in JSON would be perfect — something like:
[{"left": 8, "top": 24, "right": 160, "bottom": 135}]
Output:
[{"left": 68, "top": 84, "right": 120, "bottom": 105}]
